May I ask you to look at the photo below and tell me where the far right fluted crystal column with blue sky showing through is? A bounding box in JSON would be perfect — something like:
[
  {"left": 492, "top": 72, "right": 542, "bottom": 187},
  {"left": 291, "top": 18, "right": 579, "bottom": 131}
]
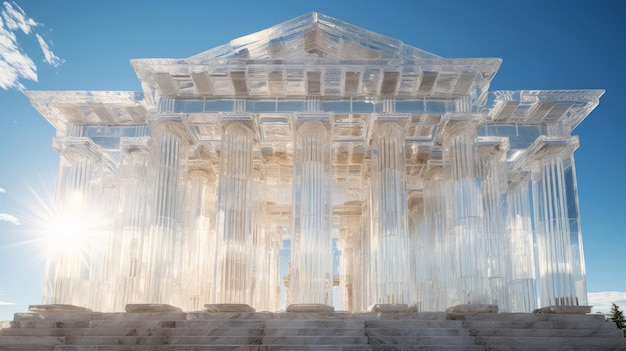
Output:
[{"left": 532, "top": 154, "right": 587, "bottom": 306}]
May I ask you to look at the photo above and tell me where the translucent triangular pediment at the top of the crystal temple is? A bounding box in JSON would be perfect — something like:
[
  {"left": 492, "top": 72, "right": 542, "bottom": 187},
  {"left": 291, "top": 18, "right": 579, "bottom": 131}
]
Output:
[{"left": 189, "top": 12, "right": 439, "bottom": 61}]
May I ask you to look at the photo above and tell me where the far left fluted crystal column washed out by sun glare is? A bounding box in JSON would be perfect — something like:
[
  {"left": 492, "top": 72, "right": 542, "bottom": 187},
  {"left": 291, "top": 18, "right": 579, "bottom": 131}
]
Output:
[{"left": 42, "top": 138, "right": 101, "bottom": 306}]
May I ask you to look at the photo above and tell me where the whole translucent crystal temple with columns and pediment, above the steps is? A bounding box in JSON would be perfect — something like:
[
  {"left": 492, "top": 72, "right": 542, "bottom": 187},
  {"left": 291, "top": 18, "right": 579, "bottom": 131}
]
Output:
[{"left": 28, "top": 13, "right": 603, "bottom": 312}]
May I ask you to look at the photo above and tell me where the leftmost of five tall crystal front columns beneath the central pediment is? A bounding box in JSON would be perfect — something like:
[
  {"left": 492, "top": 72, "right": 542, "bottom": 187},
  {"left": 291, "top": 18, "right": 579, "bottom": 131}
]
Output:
[{"left": 143, "top": 123, "right": 188, "bottom": 304}]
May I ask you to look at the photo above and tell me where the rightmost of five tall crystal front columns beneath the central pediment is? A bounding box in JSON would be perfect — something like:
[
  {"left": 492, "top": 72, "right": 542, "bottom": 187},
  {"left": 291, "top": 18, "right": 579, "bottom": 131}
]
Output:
[{"left": 443, "top": 119, "right": 490, "bottom": 304}]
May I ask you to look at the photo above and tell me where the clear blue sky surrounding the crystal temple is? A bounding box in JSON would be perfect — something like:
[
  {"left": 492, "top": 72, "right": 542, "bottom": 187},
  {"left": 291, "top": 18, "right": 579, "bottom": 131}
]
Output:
[{"left": 0, "top": 0, "right": 626, "bottom": 320}]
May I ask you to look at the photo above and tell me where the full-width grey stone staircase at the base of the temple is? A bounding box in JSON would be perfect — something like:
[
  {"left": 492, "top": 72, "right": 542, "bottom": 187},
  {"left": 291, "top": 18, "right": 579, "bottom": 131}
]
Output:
[{"left": 0, "top": 312, "right": 626, "bottom": 351}]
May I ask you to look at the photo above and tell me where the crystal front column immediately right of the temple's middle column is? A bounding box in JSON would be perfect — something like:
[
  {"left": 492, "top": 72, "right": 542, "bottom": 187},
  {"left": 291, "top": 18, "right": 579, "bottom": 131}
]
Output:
[{"left": 370, "top": 122, "right": 412, "bottom": 304}]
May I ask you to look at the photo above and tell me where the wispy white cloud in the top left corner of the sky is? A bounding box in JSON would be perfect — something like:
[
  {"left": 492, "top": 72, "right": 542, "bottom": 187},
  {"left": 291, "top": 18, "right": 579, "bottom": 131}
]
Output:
[{"left": 0, "top": 1, "right": 63, "bottom": 90}]
